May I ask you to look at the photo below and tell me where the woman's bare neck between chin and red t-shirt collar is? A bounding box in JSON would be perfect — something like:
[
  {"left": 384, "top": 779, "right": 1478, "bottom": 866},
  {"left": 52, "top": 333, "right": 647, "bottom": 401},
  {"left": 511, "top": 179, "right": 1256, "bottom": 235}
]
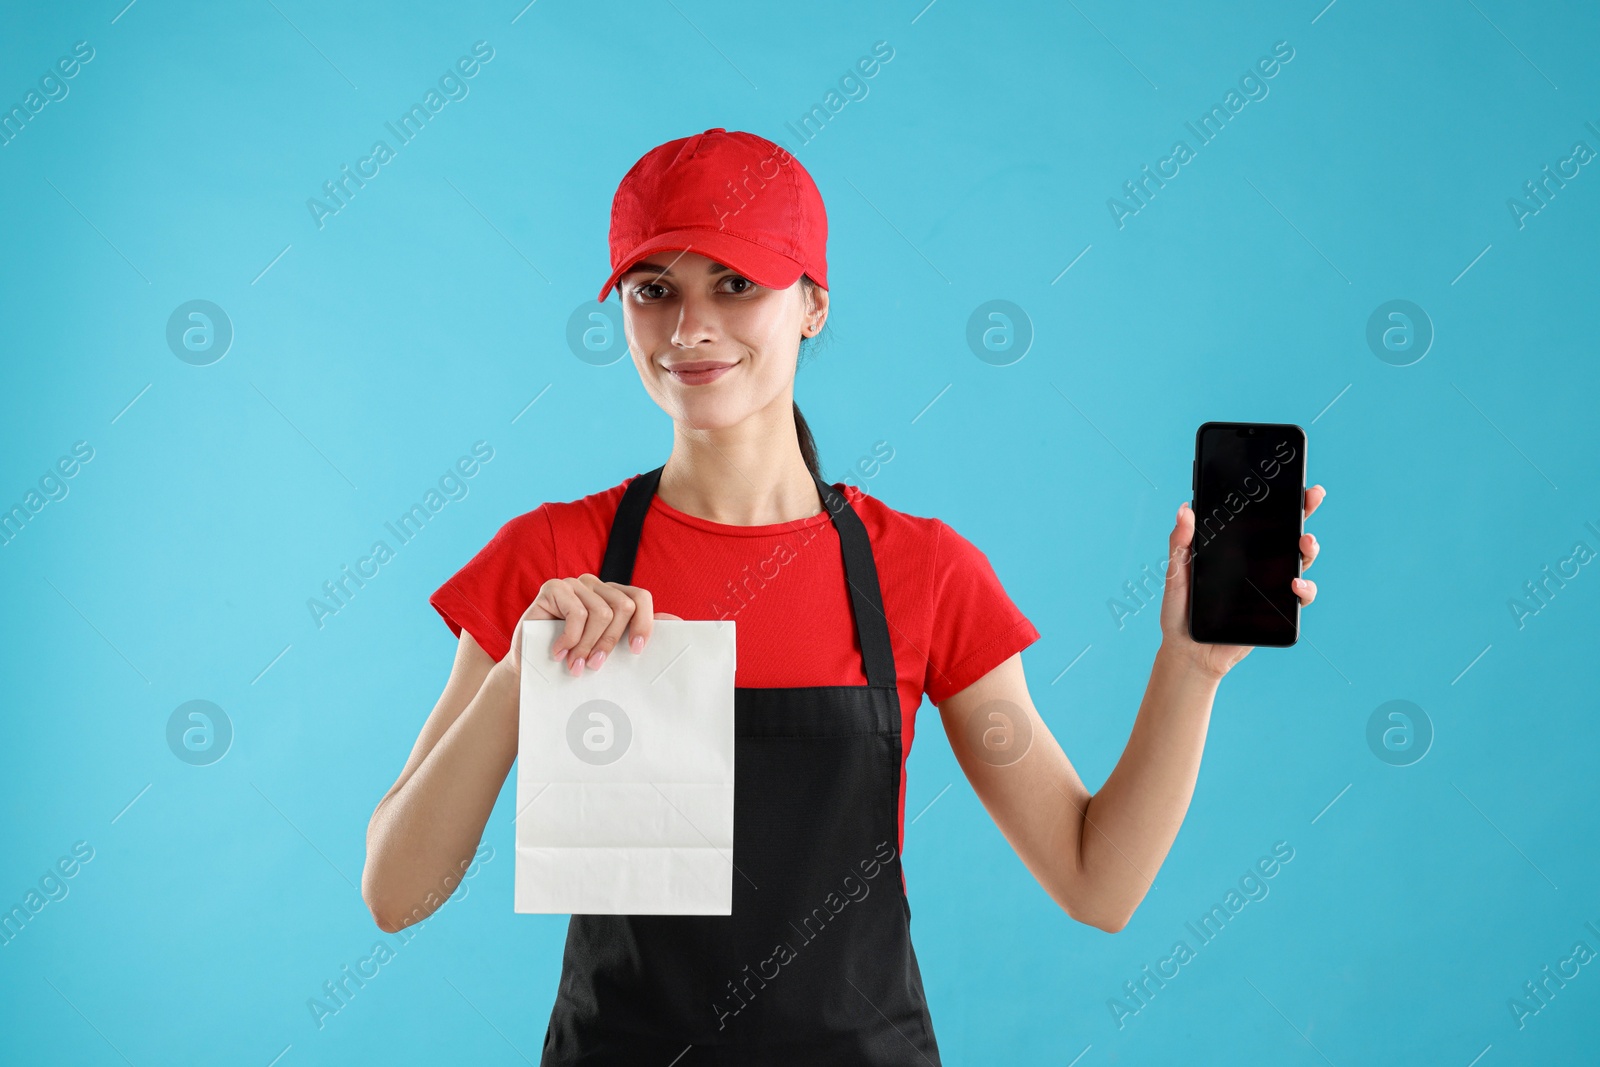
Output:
[{"left": 656, "top": 390, "right": 822, "bottom": 526}]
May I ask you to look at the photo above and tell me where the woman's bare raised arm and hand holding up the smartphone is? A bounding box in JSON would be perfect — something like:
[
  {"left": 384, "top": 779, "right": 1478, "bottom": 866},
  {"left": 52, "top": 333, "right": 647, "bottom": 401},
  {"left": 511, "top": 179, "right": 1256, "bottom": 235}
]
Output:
[{"left": 939, "top": 486, "right": 1325, "bottom": 933}]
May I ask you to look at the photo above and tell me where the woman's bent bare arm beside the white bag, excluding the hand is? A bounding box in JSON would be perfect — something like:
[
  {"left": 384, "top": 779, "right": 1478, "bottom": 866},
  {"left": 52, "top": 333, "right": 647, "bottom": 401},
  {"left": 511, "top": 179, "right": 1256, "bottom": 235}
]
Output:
[{"left": 362, "top": 630, "right": 518, "bottom": 933}]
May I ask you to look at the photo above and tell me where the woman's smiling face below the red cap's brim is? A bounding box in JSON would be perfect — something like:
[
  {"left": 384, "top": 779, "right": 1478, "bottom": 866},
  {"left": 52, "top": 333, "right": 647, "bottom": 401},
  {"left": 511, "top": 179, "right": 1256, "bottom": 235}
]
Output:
[{"left": 618, "top": 251, "right": 827, "bottom": 430}]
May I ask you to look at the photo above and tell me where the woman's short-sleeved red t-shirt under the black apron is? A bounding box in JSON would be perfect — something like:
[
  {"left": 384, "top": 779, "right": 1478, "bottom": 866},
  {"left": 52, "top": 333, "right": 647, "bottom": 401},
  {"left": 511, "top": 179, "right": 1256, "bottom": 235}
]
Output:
[{"left": 429, "top": 477, "right": 1038, "bottom": 849}]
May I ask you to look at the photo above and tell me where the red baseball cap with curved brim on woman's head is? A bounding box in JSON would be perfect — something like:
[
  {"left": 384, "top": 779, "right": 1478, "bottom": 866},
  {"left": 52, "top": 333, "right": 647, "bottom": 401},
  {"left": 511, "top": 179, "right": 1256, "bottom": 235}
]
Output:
[{"left": 595, "top": 126, "right": 827, "bottom": 301}]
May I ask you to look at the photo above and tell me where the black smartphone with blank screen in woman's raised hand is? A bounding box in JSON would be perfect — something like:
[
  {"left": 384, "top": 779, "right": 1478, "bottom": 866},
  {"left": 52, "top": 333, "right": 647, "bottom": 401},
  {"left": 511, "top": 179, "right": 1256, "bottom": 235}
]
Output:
[{"left": 1189, "top": 422, "right": 1306, "bottom": 648}]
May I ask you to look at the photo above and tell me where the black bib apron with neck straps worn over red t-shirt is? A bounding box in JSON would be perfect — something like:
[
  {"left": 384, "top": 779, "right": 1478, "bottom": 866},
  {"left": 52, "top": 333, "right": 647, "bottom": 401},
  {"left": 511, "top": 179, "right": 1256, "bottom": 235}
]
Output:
[{"left": 539, "top": 467, "right": 941, "bottom": 1067}]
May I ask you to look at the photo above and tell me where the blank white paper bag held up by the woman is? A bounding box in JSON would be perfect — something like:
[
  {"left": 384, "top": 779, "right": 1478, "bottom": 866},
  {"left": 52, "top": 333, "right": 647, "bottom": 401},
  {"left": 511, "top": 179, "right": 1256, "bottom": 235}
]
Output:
[{"left": 514, "top": 619, "right": 736, "bottom": 915}]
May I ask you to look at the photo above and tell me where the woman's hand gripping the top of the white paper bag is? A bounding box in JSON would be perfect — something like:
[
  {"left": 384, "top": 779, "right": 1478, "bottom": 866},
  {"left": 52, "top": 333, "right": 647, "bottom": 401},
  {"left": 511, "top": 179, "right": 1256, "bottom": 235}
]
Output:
[{"left": 501, "top": 574, "right": 682, "bottom": 677}]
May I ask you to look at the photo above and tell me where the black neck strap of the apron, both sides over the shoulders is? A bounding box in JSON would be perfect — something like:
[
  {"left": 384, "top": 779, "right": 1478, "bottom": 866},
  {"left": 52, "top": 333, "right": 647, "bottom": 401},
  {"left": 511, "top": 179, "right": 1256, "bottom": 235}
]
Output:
[{"left": 600, "top": 464, "right": 896, "bottom": 689}]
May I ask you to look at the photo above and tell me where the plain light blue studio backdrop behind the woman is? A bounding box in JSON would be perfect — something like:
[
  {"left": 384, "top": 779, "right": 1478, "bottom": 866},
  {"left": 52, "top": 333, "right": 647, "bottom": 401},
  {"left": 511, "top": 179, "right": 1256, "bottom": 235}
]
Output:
[{"left": 0, "top": 0, "right": 1600, "bottom": 1067}]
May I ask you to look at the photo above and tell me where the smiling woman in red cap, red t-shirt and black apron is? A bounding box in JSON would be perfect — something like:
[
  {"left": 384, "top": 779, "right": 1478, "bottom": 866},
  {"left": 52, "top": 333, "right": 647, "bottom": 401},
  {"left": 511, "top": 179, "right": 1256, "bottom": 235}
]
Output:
[{"left": 363, "top": 128, "right": 1322, "bottom": 1067}]
